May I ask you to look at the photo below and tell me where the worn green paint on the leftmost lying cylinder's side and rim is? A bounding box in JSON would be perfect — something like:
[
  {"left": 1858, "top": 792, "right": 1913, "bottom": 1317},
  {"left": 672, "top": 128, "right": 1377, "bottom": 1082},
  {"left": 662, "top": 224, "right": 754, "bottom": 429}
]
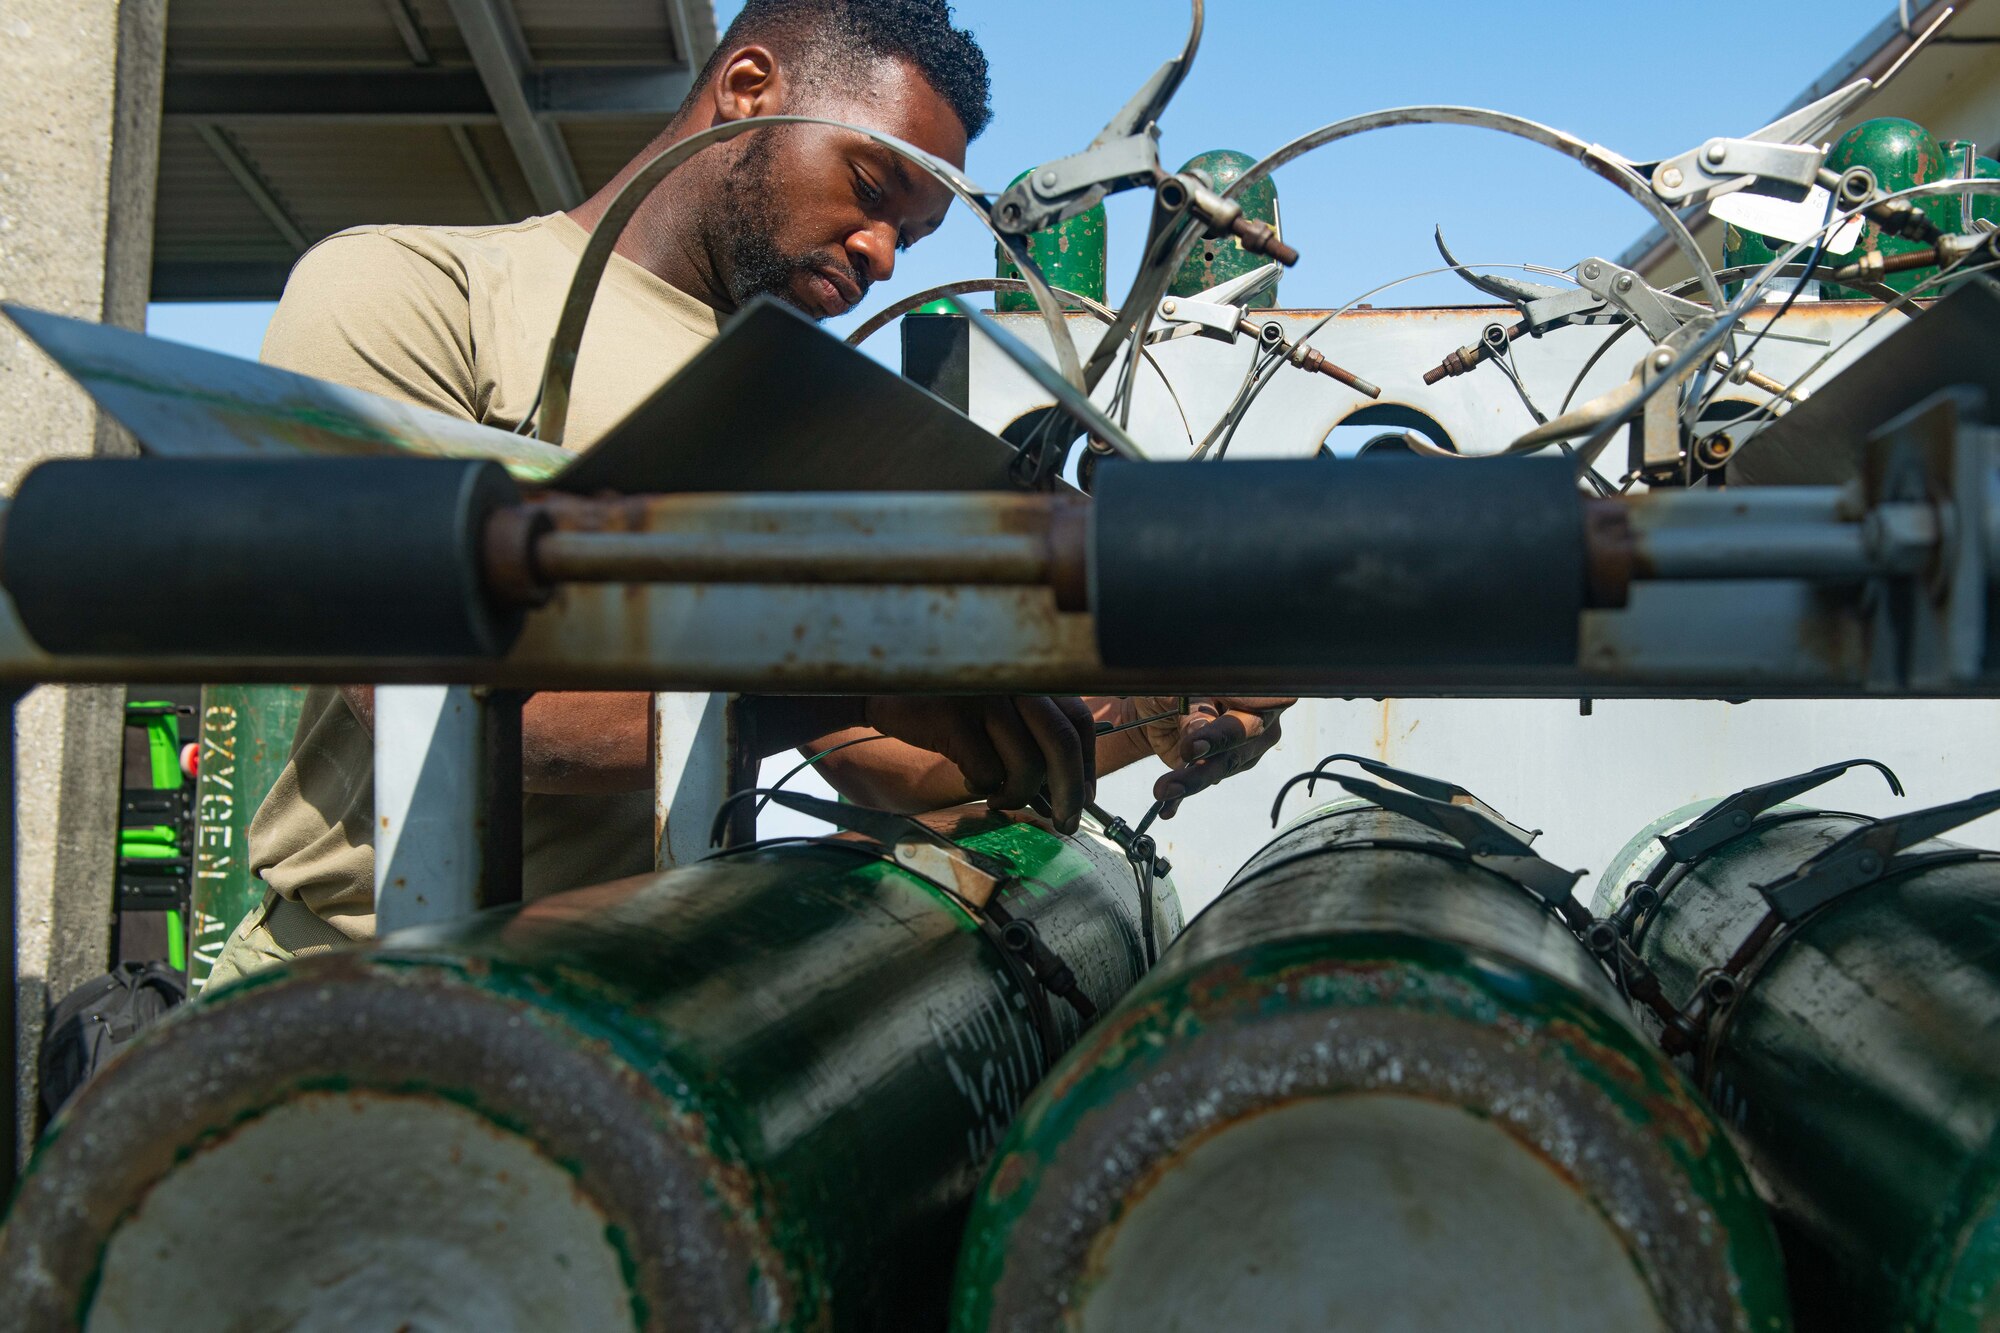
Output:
[{"left": 11, "top": 815, "right": 1180, "bottom": 1333}]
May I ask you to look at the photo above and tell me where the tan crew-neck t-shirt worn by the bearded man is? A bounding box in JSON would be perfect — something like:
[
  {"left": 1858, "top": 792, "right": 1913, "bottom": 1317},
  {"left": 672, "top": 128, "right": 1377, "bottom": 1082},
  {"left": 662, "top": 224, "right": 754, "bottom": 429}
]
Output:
[{"left": 250, "top": 214, "right": 716, "bottom": 939}]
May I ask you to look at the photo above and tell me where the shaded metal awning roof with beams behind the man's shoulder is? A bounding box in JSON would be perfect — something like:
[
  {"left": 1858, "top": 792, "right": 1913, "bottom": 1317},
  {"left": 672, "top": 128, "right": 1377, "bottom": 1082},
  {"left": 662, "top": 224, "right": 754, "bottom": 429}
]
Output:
[{"left": 152, "top": 0, "right": 716, "bottom": 300}]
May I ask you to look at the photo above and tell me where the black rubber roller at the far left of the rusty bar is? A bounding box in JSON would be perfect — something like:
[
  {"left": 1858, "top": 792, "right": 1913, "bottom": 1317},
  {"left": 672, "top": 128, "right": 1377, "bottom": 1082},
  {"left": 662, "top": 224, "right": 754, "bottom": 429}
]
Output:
[{"left": 0, "top": 458, "right": 522, "bottom": 658}]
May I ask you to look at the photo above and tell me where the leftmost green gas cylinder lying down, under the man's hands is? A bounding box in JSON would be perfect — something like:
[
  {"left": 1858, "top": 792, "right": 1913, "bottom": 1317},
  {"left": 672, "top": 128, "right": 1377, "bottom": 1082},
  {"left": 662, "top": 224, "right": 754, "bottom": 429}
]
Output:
[{"left": 0, "top": 800, "right": 1180, "bottom": 1333}]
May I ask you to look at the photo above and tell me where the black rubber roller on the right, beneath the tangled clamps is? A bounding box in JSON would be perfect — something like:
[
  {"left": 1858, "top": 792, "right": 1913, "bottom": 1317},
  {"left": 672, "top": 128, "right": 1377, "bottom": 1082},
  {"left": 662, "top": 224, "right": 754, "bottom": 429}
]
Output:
[{"left": 1090, "top": 458, "right": 1586, "bottom": 669}]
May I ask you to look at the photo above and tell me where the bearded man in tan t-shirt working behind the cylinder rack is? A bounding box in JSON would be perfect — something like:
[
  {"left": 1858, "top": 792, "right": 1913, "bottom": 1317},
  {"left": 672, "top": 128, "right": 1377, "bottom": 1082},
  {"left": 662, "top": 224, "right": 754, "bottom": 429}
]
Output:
[{"left": 210, "top": 0, "right": 1286, "bottom": 985}]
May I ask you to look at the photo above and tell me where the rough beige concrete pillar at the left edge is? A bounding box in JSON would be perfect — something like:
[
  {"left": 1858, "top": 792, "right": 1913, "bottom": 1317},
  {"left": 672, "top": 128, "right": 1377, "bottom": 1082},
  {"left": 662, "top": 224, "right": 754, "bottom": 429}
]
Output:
[{"left": 0, "top": 0, "right": 166, "bottom": 1145}]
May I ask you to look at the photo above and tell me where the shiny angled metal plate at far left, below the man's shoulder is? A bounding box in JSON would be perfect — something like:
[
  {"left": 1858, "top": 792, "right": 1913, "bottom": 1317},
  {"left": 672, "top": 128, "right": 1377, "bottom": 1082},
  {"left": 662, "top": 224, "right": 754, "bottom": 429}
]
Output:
[{"left": 0, "top": 304, "right": 574, "bottom": 482}]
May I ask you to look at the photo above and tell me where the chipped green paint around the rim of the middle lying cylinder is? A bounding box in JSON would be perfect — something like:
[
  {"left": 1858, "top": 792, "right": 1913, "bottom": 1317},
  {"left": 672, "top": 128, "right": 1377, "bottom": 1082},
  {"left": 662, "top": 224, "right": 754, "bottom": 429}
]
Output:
[{"left": 952, "top": 803, "right": 1790, "bottom": 1333}]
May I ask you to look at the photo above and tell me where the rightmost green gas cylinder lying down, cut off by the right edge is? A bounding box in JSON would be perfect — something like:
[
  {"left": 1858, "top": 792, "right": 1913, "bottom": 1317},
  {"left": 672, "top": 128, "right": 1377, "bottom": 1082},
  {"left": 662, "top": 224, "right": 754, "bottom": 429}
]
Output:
[{"left": 1598, "top": 771, "right": 2000, "bottom": 1333}]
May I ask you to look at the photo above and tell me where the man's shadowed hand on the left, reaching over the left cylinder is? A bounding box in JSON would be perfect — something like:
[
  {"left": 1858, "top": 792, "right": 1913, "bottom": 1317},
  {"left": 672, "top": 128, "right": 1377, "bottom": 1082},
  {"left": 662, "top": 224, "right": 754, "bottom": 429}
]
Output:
[{"left": 864, "top": 695, "right": 1098, "bottom": 833}]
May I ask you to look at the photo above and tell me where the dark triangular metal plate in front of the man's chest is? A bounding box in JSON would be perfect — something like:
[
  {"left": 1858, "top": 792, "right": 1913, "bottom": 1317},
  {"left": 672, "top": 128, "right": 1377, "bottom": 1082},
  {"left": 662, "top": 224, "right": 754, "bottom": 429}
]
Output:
[{"left": 552, "top": 298, "right": 1040, "bottom": 494}]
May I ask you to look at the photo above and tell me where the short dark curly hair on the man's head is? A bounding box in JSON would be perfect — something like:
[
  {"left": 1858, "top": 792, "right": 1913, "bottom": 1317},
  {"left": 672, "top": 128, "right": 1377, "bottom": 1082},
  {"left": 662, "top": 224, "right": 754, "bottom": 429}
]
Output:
[{"left": 694, "top": 0, "right": 992, "bottom": 140}]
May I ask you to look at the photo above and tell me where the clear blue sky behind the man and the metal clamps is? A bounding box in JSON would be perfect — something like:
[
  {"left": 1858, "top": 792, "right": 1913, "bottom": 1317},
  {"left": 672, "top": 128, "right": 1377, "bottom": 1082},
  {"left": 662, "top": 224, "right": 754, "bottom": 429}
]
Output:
[{"left": 148, "top": 0, "right": 1892, "bottom": 356}]
